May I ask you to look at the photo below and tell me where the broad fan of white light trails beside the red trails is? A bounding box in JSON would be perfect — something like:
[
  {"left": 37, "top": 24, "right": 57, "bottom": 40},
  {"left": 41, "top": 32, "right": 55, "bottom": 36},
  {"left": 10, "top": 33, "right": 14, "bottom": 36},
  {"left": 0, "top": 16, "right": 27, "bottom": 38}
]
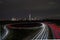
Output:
[{"left": 32, "top": 23, "right": 49, "bottom": 40}]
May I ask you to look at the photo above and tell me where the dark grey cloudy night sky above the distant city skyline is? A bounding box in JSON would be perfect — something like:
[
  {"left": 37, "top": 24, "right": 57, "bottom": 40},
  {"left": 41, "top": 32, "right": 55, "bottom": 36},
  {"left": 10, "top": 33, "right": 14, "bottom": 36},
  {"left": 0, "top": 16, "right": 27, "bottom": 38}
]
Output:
[{"left": 0, "top": 0, "right": 60, "bottom": 19}]
